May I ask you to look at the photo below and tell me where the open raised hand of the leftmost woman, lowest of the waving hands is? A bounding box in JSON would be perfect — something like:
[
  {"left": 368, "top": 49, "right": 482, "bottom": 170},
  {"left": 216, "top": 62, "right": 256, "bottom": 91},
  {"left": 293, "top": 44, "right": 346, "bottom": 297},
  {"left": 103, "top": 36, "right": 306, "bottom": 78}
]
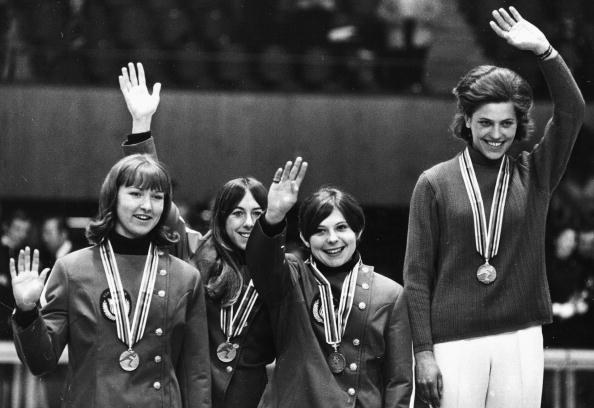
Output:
[{"left": 10, "top": 247, "right": 49, "bottom": 311}]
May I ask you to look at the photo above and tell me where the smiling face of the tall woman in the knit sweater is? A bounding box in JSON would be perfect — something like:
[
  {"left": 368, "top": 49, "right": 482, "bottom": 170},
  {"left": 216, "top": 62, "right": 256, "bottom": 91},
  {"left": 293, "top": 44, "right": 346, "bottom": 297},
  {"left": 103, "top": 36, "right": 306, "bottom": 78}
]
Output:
[{"left": 466, "top": 102, "right": 518, "bottom": 160}]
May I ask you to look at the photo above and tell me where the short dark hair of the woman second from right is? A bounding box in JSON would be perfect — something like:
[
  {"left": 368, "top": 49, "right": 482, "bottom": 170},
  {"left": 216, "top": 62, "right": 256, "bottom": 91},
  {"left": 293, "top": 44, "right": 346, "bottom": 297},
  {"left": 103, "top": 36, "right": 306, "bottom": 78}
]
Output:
[{"left": 298, "top": 186, "right": 365, "bottom": 241}]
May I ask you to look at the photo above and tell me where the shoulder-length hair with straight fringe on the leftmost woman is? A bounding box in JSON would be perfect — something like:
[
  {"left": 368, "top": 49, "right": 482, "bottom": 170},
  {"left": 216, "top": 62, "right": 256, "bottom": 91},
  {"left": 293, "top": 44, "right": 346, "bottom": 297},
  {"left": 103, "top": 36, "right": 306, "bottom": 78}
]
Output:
[{"left": 86, "top": 154, "right": 177, "bottom": 246}]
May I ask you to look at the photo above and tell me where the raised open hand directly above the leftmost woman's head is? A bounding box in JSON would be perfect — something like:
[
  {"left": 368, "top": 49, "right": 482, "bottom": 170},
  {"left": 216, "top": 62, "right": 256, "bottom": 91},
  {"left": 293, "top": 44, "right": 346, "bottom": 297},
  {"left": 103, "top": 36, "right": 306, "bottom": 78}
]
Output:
[{"left": 118, "top": 62, "right": 161, "bottom": 133}]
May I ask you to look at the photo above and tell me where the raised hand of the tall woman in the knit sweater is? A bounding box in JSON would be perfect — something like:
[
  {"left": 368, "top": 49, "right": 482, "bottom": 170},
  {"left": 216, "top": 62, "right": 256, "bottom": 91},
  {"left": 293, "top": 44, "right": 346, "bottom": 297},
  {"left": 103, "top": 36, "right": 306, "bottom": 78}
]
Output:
[{"left": 489, "top": 7, "right": 550, "bottom": 55}]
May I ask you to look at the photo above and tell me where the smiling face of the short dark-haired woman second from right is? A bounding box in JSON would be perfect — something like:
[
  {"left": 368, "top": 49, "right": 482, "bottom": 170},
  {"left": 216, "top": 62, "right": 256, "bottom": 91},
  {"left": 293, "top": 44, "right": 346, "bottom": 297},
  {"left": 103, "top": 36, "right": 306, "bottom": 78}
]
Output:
[{"left": 302, "top": 208, "right": 360, "bottom": 268}]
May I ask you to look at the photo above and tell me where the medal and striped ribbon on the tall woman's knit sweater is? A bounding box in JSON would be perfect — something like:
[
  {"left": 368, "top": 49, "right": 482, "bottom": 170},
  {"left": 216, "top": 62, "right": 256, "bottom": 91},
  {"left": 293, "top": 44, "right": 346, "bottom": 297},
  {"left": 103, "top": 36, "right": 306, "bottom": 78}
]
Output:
[{"left": 459, "top": 147, "right": 510, "bottom": 285}]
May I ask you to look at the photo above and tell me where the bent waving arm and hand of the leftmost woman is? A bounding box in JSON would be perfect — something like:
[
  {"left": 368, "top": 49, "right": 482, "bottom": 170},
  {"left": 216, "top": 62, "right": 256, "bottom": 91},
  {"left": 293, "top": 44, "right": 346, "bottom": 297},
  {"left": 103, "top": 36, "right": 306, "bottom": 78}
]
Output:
[{"left": 11, "top": 248, "right": 68, "bottom": 375}]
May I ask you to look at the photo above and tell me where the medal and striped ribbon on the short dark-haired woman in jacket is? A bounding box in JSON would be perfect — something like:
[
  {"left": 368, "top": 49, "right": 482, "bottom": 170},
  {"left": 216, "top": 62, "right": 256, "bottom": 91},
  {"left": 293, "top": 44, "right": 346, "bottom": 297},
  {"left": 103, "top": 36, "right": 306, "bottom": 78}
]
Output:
[{"left": 309, "top": 258, "right": 361, "bottom": 374}]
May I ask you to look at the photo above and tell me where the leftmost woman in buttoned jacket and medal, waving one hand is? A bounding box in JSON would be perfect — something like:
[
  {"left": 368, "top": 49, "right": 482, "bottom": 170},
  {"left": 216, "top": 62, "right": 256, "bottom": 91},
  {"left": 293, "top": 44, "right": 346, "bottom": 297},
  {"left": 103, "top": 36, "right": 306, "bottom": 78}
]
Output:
[{"left": 10, "top": 154, "right": 211, "bottom": 408}]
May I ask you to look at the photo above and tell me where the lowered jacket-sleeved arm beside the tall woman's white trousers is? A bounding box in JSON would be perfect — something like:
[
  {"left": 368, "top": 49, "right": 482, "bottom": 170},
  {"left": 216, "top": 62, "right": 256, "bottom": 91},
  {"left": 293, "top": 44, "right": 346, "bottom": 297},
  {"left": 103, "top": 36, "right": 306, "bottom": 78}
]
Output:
[{"left": 383, "top": 288, "right": 413, "bottom": 408}]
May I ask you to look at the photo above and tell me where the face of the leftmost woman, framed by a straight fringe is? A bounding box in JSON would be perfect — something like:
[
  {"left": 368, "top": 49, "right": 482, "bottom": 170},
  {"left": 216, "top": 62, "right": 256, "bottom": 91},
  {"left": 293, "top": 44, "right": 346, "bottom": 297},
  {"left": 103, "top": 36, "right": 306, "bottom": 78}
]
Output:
[{"left": 115, "top": 186, "right": 165, "bottom": 238}]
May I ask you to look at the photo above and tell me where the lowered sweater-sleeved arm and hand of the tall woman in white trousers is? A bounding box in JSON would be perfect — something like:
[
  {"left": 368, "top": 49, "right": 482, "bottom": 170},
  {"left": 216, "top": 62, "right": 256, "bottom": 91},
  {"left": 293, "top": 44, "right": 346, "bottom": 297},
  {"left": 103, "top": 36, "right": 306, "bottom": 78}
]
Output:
[{"left": 404, "top": 174, "right": 442, "bottom": 407}]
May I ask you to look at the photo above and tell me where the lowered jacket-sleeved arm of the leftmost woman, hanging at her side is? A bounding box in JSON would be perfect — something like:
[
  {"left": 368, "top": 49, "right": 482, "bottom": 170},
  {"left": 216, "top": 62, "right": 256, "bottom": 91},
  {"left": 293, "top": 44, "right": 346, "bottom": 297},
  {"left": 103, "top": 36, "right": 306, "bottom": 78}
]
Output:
[{"left": 176, "top": 272, "right": 211, "bottom": 408}]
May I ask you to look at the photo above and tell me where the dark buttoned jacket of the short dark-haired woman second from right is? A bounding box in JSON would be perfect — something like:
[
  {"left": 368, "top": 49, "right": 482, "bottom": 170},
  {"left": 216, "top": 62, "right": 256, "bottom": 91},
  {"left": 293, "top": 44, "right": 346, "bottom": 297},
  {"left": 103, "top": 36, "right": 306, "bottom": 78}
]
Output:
[{"left": 246, "top": 217, "right": 413, "bottom": 408}]
